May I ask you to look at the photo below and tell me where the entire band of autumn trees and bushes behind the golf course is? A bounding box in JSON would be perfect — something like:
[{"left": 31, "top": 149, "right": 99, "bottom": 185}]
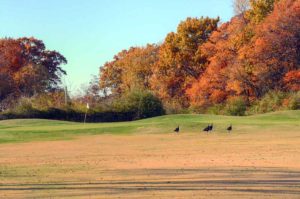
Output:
[{"left": 0, "top": 0, "right": 300, "bottom": 121}]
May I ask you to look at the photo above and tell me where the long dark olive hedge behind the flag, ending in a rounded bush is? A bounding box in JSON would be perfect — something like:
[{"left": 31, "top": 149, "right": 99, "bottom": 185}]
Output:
[{"left": 0, "top": 91, "right": 164, "bottom": 122}]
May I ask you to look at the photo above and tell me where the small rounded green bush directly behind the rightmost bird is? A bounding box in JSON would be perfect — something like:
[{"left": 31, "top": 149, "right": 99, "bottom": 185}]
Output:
[{"left": 224, "top": 97, "right": 247, "bottom": 116}]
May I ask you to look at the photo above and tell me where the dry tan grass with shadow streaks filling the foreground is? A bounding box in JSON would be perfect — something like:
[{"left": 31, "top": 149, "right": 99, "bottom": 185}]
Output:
[{"left": 0, "top": 132, "right": 300, "bottom": 198}]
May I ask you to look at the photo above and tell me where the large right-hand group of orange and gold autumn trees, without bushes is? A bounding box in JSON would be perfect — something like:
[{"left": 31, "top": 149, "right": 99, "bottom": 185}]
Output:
[{"left": 100, "top": 0, "right": 300, "bottom": 112}]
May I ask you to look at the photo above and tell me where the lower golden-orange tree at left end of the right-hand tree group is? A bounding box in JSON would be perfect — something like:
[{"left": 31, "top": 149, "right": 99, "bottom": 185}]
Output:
[{"left": 100, "top": 45, "right": 159, "bottom": 95}]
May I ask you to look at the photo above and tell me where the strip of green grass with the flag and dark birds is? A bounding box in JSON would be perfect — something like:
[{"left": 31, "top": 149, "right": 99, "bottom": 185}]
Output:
[{"left": 0, "top": 110, "right": 300, "bottom": 144}]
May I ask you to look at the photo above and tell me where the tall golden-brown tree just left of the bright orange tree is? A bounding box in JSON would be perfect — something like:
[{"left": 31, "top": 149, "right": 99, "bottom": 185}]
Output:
[{"left": 151, "top": 17, "right": 219, "bottom": 107}]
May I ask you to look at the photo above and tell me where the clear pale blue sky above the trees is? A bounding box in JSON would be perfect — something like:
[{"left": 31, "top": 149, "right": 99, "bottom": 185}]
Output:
[{"left": 0, "top": 0, "right": 233, "bottom": 91}]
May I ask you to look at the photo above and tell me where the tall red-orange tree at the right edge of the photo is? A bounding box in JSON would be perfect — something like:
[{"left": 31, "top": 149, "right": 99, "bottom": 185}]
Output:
[{"left": 240, "top": 0, "right": 300, "bottom": 97}]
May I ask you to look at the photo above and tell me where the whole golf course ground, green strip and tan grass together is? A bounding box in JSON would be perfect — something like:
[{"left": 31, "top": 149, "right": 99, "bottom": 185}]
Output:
[{"left": 0, "top": 111, "right": 300, "bottom": 199}]
